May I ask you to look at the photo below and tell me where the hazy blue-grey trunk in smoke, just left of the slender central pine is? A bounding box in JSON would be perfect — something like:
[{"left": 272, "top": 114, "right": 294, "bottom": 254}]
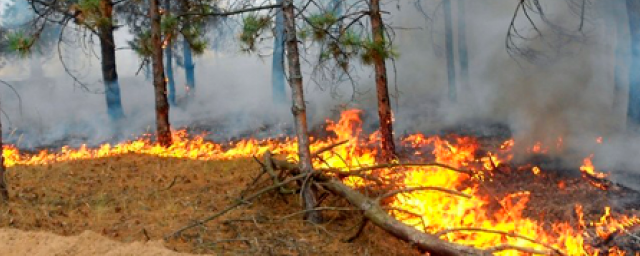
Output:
[{"left": 271, "top": 0, "right": 286, "bottom": 103}]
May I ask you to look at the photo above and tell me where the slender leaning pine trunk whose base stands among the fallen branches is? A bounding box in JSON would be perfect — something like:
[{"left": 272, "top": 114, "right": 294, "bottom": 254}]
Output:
[{"left": 282, "top": 0, "right": 322, "bottom": 223}]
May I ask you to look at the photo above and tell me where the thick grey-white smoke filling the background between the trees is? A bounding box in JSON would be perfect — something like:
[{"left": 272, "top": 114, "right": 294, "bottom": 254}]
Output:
[{"left": 0, "top": 0, "right": 640, "bottom": 186}]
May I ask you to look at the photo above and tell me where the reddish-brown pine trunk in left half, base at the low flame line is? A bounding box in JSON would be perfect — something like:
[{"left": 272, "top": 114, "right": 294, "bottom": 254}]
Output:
[{"left": 149, "top": 0, "right": 171, "bottom": 147}]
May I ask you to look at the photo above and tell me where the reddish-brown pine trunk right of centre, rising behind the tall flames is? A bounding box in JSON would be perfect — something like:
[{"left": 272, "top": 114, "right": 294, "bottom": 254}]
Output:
[{"left": 370, "top": 0, "right": 396, "bottom": 161}]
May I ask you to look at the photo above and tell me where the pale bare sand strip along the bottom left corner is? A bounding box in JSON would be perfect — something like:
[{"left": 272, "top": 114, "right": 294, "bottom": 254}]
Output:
[{"left": 0, "top": 228, "right": 202, "bottom": 256}]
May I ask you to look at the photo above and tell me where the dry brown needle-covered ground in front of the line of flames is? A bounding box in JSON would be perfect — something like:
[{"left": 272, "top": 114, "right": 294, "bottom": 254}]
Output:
[{"left": 0, "top": 154, "right": 419, "bottom": 255}]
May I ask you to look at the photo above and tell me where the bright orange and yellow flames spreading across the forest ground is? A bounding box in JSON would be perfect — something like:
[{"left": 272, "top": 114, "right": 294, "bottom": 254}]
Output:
[{"left": 4, "top": 110, "right": 640, "bottom": 255}]
